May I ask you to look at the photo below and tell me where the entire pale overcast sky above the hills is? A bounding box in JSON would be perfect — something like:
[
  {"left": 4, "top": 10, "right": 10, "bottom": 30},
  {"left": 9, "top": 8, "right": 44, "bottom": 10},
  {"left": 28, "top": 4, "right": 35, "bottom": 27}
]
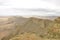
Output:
[{"left": 0, "top": 0, "right": 60, "bottom": 16}]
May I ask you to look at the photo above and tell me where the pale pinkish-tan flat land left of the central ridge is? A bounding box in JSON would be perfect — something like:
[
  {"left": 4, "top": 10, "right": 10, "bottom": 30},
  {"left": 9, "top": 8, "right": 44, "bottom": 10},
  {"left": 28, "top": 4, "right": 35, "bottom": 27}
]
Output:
[{"left": 0, "top": 17, "right": 16, "bottom": 39}]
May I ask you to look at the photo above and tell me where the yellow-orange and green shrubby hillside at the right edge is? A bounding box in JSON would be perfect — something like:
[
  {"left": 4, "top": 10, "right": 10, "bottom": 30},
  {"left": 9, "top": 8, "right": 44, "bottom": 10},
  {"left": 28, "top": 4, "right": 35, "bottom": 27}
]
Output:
[{"left": 48, "top": 17, "right": 60, "bottom": 39}]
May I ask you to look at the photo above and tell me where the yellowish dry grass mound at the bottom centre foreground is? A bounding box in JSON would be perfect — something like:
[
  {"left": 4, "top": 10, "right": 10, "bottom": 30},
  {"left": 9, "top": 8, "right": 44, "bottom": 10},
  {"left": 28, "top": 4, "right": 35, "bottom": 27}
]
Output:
[{"left": 10, "top": 33, "right": 41, "bottom": 40}]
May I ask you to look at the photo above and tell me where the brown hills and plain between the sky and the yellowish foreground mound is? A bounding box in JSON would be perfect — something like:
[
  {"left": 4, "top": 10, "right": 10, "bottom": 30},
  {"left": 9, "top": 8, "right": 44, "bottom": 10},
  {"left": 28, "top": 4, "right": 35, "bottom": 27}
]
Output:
[{"left": 0, "top": 16, "right": 60, "bottom": 40}]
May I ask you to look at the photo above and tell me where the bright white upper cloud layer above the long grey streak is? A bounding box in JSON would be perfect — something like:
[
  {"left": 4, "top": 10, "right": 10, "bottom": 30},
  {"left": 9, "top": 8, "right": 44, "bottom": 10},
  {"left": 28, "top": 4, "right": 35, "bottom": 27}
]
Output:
[{"left": 0, "top": 0, "right": 60, "bottom": 10}]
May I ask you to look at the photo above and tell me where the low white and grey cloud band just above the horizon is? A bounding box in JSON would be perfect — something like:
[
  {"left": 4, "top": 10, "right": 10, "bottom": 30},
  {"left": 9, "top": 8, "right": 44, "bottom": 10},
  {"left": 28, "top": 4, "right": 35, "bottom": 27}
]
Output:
[{"left": 0, "top": 8, "right": 60, "bottom": 16}]
